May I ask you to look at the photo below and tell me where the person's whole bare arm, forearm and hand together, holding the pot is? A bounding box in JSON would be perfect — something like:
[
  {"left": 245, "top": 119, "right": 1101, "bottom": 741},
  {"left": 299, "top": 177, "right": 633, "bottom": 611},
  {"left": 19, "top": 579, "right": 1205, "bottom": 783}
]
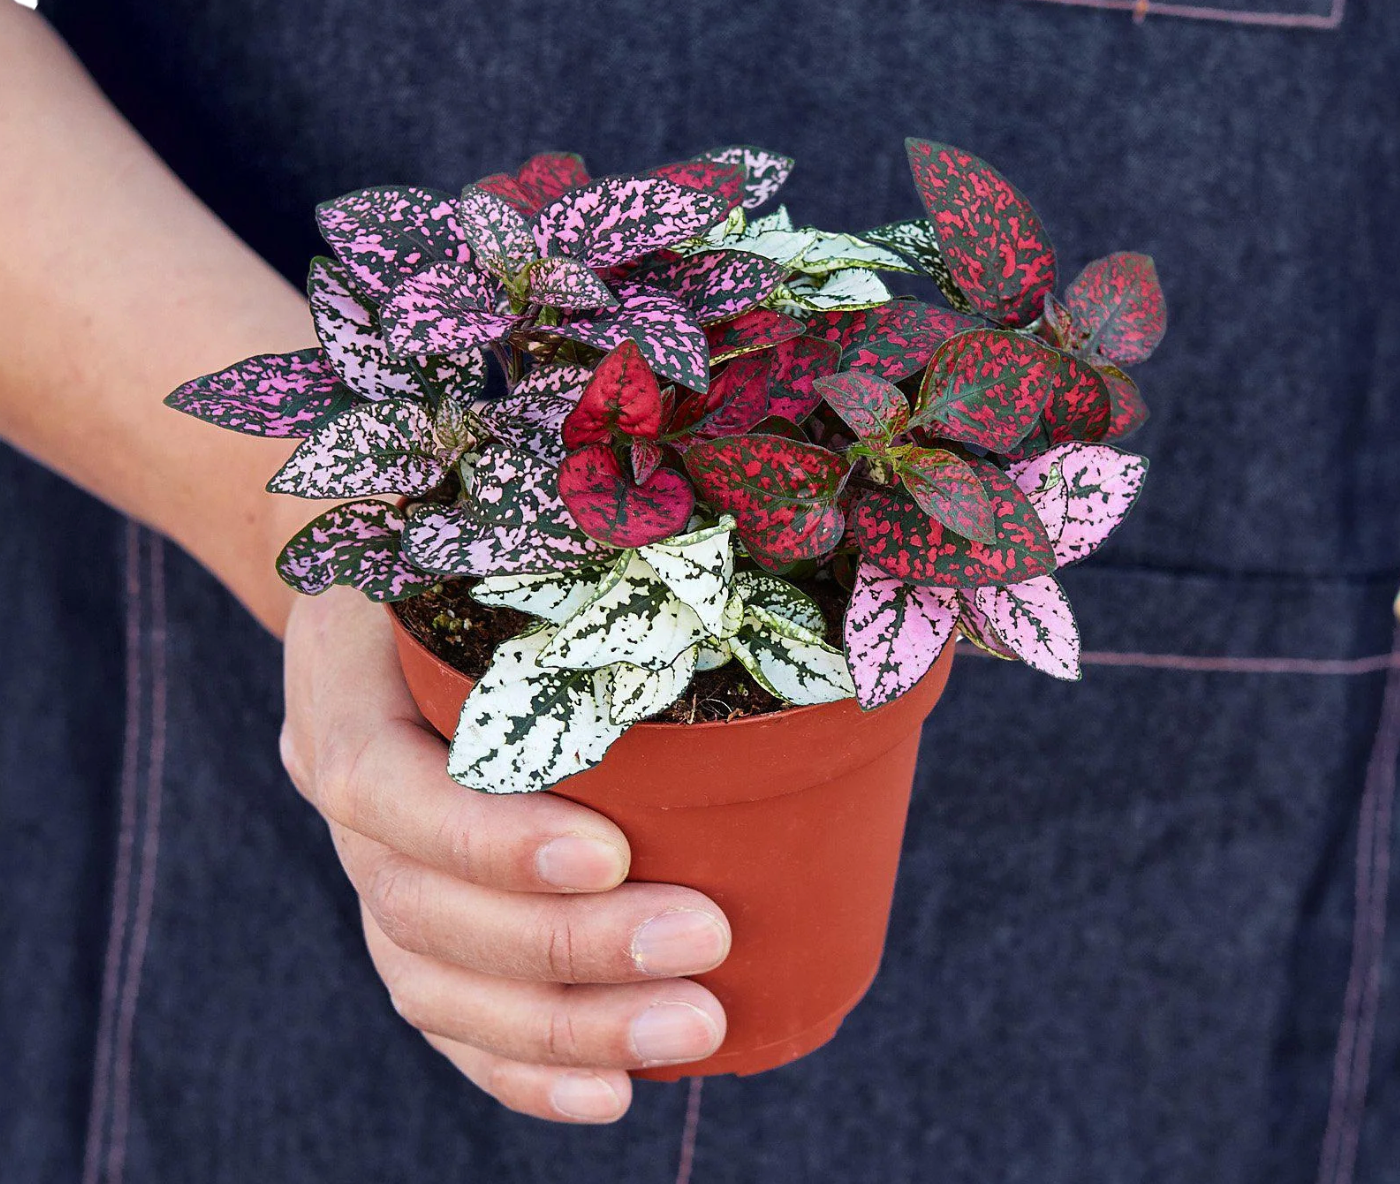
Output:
[{"left": 0, "top": 0, "right": 729, "bottom": 1122}]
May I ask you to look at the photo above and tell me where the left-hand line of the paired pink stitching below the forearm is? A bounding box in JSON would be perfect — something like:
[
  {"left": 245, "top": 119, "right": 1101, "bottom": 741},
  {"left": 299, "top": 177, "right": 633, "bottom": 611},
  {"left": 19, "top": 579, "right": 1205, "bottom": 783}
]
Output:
[{"left": 83, "top": 521, "right": 144, "bottom": 1184}]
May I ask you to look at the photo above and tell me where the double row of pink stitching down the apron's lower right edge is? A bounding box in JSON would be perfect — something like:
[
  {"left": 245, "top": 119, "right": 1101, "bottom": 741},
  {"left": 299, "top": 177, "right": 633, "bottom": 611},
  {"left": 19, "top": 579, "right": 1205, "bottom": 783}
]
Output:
[{"left": 1317, "top": 628, "right": 1400, "bottom": 1184}]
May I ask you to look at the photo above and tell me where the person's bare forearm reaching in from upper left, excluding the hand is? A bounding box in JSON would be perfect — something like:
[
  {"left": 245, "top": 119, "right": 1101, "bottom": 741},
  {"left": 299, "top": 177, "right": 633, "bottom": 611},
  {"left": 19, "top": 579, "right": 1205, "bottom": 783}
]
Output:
[{"left": 0, "top": 0, "right": 315, "bottom": 634}]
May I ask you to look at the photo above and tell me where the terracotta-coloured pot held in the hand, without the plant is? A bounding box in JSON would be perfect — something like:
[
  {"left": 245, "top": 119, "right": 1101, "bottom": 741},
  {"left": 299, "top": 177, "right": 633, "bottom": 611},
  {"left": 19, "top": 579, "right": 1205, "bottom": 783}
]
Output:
[{"left": 389, "top": 612, "right": 953, "bottom": 1080}]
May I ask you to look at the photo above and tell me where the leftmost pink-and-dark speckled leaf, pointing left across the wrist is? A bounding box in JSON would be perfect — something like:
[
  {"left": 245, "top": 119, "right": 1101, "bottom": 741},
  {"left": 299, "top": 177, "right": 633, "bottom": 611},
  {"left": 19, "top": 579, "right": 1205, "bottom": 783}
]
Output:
[{"left": 165, "top": 350, "right": 354, "bottom": 439}]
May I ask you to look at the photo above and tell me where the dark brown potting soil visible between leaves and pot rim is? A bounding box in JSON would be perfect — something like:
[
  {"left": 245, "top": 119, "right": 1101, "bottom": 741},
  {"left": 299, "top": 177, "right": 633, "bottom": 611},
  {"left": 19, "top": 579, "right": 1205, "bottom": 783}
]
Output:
[{"left": 393, "top": 579, "right": 847, "bottom": 724}]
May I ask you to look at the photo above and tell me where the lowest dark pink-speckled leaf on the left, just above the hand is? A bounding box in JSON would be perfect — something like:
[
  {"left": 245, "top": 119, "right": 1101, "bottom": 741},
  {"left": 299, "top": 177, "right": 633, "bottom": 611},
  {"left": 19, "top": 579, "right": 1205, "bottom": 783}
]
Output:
[{"left": 277, "top": 501, "right": 437, "bottom": 600}]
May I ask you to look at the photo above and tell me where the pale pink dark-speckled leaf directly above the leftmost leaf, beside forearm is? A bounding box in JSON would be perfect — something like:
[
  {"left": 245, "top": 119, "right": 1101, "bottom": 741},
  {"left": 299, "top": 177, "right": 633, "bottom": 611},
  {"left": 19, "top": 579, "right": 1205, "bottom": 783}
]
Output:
[{"left": 307, "top": 258, "right": 425, "bottom": 399}]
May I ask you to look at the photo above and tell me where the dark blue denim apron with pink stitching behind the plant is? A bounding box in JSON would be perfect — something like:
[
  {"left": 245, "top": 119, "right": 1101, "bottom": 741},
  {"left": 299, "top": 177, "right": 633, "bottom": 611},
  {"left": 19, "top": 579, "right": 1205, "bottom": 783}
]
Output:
[{"left": 0, "top": 0, "right": 1400, "bottom": 1184}]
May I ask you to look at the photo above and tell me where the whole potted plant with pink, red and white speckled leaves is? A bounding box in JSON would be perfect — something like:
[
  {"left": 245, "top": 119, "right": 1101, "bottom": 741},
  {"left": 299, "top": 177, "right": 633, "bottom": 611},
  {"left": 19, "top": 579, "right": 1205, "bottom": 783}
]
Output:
[{"left": 168, "top": 140, "right": 1165, "bottom": 1078}]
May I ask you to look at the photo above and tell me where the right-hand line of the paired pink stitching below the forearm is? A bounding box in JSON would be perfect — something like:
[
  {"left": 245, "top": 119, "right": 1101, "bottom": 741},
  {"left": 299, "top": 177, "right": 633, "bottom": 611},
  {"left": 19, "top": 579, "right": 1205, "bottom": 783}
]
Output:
[{"left": 106, "top": 536, "right": 167, "bottom": 1184}]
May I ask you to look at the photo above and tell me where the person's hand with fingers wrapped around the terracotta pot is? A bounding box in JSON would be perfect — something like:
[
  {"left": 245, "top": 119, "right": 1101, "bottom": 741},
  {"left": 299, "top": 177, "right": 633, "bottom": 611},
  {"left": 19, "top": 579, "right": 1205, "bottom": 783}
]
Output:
[{"left": 281, "top": 588, "right": 729, "bottom": 1122}]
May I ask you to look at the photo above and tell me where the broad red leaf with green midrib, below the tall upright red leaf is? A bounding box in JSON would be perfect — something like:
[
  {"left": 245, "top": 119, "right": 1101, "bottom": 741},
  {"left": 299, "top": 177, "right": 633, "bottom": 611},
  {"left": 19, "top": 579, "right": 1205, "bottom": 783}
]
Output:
[{"left": 914, "top": 329, "right": 1052, "bottom": 452}]
